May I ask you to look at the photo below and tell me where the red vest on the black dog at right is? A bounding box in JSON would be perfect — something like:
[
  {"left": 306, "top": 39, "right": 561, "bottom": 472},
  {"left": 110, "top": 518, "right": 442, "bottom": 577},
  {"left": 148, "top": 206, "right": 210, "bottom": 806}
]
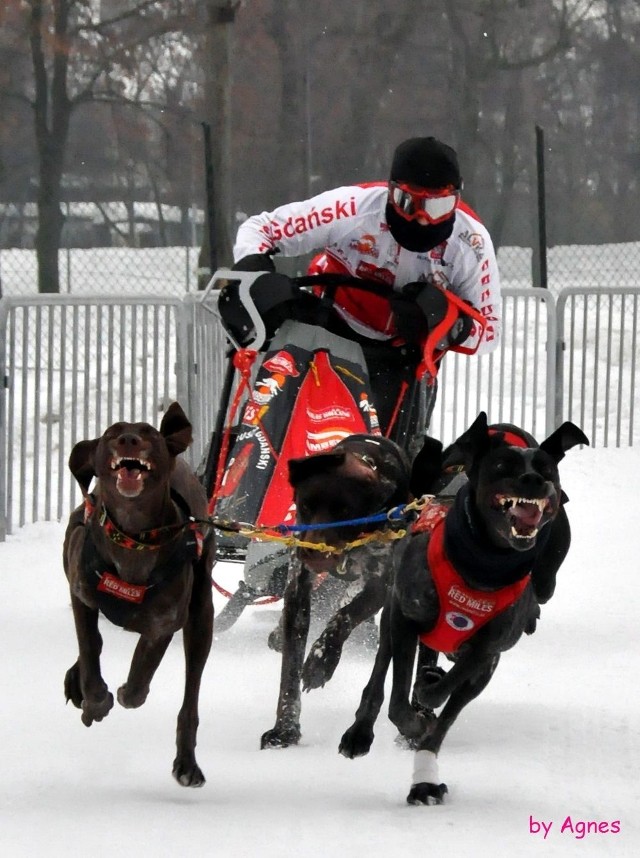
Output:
[{"left": 420, "top": 519, "right": 531, "bottom": 653}]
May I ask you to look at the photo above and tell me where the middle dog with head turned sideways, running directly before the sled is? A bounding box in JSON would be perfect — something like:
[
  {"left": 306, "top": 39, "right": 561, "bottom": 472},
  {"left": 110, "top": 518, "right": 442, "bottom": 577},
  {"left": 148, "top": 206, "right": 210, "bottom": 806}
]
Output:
[{"left": 261, "top": 435, "right": 410, "bottom": 748}]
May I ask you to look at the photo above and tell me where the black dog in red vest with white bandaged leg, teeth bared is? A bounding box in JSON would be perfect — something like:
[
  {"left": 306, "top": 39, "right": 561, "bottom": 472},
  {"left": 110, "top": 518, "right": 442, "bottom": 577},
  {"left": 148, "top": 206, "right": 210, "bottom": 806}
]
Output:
[{"left": 340, "top": 413, "right": 588, "bottom": 804}]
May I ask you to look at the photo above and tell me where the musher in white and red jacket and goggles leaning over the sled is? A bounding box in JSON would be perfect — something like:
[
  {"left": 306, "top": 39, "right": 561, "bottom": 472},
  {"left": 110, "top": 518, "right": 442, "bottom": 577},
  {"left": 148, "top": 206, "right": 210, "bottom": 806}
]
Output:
[{"left": 233, "top": 137, "right": 501, "bottom": 438}]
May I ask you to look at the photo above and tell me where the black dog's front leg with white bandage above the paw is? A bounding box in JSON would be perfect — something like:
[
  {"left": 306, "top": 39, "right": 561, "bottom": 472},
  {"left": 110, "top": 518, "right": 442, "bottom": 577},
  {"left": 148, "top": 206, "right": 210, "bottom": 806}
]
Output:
[{"left": 407, "top": 655, "right": 500, "bottom": 805}]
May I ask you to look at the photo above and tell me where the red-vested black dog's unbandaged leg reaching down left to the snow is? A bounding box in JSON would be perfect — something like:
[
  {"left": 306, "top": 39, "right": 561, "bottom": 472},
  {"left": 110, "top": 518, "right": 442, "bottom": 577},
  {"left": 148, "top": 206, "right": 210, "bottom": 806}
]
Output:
[{"left": 338, "top": 605, "right": 391, "bottom": 760}]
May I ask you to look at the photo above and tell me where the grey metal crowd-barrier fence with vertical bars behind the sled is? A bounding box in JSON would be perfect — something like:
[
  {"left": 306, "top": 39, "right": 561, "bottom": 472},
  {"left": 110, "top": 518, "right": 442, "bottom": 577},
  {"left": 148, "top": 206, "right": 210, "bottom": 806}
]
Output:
[{"left": 0, "top": 287, "right": 640, "bottom": 540}]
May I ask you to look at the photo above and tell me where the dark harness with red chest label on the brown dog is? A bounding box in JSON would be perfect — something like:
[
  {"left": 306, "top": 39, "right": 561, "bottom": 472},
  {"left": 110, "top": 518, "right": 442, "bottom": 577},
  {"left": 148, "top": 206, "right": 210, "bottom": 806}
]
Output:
[{"left": 81, "top": 491, "right": 204, "bottom": 628}]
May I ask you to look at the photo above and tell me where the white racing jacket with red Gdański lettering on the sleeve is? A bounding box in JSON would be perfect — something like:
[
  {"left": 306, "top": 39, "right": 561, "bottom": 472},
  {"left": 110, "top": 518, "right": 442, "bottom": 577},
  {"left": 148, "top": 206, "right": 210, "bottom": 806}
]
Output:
[{"left": 233, "top": 182, "right": 501, "bottom": 354}]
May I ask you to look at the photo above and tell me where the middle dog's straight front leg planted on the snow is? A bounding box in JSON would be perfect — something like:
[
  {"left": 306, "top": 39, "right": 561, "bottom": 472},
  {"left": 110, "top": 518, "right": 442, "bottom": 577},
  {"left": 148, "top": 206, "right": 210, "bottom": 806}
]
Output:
[{"left": 260, "top": 561, "right": 312, "bottom": 748}]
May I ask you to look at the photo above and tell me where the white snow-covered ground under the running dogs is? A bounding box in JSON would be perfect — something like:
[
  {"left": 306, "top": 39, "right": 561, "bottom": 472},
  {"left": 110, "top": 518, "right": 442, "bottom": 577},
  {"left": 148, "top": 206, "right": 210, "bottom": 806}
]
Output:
[{"left": 0, "top": 438, "right": 640, "bottom": 858}]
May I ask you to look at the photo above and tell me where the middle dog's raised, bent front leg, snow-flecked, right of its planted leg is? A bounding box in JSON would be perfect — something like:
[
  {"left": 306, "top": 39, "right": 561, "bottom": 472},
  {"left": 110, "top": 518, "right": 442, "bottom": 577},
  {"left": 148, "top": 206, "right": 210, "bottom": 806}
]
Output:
[{"left": 302, "top": 576, "right": 388, "bottom": 691}]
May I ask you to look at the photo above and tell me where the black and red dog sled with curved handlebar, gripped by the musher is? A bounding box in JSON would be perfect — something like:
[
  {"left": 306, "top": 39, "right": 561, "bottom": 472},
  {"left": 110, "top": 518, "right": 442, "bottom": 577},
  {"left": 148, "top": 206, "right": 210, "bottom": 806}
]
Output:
[{"left": 202, "top": 269, "right": 484, "bottom": 631}]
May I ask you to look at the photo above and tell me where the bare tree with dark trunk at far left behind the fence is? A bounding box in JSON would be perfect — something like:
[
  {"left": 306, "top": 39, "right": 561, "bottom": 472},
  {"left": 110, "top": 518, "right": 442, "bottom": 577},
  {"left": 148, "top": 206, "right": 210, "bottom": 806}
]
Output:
[{"left": 5, "top": 0, "right": 193, "bottom": 292}]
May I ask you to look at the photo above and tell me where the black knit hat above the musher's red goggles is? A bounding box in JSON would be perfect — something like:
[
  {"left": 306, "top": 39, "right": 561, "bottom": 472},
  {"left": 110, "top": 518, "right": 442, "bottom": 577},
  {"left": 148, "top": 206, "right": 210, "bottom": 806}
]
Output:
[{"left": 390, "top": 137, "right": 462, "bottom": 188}]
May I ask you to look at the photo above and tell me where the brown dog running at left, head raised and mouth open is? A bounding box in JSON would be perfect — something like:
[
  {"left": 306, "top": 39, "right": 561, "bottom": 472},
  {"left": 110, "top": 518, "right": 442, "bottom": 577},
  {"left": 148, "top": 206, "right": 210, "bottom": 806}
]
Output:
[{"left": 63, "top": 402, "right": 214, "bottom": 787}]
